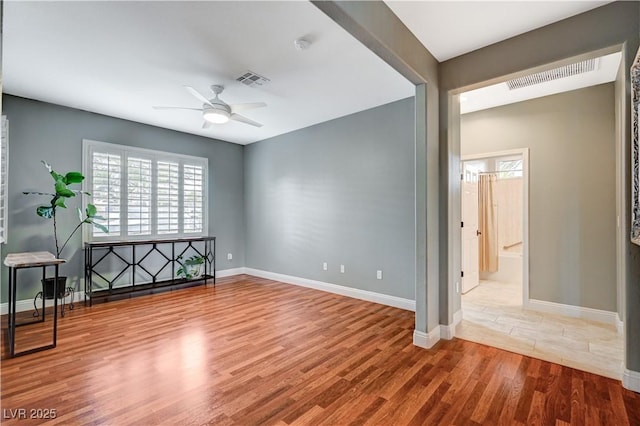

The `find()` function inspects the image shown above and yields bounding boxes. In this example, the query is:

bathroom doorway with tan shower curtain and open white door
[461,153,528,305]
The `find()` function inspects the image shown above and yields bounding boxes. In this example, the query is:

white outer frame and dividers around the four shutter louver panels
[82,139,209,243]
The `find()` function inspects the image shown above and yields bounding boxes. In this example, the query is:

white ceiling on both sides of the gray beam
[3,1,608,144]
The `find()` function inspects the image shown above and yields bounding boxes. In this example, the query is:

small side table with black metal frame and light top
[4,251,66,358]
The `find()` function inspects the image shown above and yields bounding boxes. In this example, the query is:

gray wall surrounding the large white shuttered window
[2,95,245,301]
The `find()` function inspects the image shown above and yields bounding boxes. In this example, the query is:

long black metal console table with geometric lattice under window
[84,237,216,305]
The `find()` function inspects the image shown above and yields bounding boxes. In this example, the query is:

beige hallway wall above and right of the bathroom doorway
[460,83,617,311]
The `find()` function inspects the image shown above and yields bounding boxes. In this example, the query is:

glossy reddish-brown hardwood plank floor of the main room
[1,276,640,425]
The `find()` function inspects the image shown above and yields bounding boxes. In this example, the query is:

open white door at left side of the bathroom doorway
[461,171,480,293]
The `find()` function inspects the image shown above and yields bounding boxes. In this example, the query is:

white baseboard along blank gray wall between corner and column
[245,268,416,312]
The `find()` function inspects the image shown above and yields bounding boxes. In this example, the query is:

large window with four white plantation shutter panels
[83,140,208,241]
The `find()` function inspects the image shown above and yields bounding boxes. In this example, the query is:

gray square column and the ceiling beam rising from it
[312,0,440,334]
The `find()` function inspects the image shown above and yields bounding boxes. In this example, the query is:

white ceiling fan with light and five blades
[153,84,267,129]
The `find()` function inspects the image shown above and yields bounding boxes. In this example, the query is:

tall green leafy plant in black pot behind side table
[24,161,109,299]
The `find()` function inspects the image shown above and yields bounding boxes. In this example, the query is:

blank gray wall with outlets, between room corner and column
[245,98,415,300]
